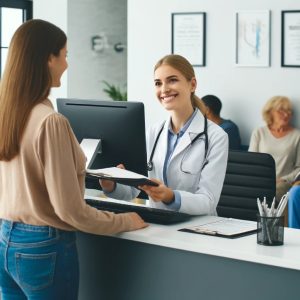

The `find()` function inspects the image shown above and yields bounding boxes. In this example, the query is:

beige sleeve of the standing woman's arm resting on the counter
[36,114,133,234]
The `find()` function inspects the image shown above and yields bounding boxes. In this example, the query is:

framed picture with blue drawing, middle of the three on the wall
[235,10,271,67]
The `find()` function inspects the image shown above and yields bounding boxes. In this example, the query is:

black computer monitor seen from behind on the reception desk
[57,99,147,189]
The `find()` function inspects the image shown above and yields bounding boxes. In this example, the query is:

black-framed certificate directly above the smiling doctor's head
[172,12,206,67]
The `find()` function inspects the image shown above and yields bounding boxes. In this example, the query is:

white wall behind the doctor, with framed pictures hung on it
[127,0,300,144]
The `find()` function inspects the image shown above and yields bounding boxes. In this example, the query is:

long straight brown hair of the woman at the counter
[0,19,67,161]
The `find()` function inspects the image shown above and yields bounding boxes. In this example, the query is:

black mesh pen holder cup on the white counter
[257,215,284,246]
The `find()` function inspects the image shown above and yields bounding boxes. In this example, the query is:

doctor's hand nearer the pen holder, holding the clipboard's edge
[138,178,175,204]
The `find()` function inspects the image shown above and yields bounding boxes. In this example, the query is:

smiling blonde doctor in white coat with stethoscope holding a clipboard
[100,55,228,215]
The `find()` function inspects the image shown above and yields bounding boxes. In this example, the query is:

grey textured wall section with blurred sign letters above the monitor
[68,0,127,100]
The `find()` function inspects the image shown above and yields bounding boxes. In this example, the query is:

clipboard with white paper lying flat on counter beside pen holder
[179,218,257,238]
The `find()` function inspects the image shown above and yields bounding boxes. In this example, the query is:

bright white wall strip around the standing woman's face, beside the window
[33,0,68,107]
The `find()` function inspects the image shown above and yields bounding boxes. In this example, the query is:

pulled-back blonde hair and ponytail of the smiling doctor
[154,54,206,115]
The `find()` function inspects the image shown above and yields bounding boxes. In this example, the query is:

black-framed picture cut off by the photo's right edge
[281,10,300,68]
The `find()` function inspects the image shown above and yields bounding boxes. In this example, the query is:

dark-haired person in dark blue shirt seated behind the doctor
[202,95,241,150]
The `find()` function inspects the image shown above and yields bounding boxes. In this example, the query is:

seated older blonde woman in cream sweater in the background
[249,96,300,210]
